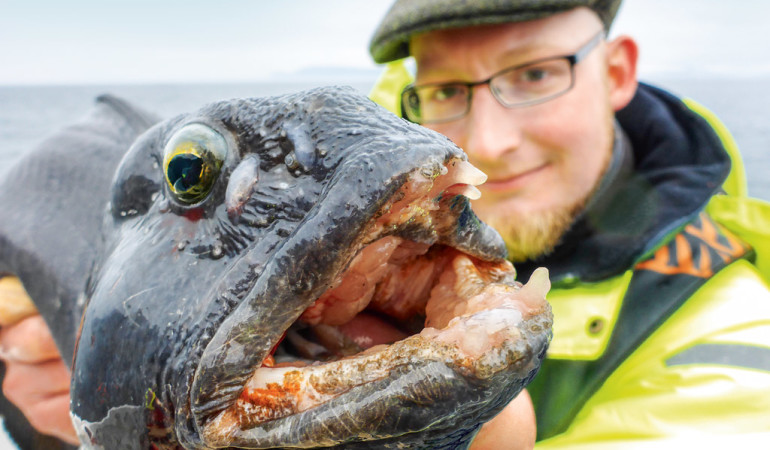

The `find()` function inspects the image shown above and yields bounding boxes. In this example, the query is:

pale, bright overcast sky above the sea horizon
[0,0,770,85]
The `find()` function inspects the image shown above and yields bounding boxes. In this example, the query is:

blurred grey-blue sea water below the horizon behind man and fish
[0,79,770,200]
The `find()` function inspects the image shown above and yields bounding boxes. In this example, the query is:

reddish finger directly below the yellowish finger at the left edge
[0,314,60,363]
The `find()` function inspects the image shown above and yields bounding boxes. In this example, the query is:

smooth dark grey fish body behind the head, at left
[0,95,159,363]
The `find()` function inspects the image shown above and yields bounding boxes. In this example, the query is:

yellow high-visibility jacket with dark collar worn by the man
[371,62,770,449]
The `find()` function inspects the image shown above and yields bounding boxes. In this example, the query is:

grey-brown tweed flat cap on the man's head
[369,0,621,63]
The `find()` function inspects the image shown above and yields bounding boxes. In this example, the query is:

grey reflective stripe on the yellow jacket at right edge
[666,344,770,372]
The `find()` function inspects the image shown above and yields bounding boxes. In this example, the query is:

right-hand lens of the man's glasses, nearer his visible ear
[490,58,572,106]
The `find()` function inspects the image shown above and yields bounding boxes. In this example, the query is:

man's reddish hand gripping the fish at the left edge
[0,315,79,444]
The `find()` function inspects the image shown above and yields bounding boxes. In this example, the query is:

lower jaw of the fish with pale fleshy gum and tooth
[204,273,551,448]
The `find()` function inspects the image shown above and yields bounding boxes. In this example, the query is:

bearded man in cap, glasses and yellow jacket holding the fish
[370,0,770,448]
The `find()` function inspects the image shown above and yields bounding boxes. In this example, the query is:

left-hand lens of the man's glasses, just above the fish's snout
[402,84,468,123]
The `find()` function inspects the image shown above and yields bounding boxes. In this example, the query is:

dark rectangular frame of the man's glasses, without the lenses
[400,30,604,125]
